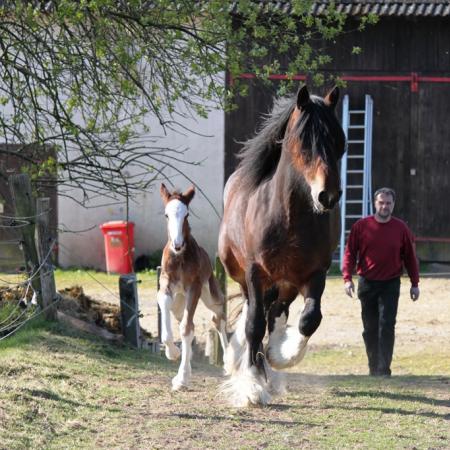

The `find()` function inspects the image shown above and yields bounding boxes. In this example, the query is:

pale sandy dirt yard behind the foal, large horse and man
[85,277,450,350]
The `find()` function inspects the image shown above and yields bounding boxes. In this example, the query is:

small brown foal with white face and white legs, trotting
[157,184,227,390]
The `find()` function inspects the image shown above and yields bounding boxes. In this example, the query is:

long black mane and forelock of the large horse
[238,96,344,189]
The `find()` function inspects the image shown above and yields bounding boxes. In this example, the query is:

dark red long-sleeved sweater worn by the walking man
[342,216,419,287]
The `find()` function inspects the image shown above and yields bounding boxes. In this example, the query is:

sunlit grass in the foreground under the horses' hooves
[0,320,450,450]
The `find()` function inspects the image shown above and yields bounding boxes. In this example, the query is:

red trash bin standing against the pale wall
[100,220,134,274]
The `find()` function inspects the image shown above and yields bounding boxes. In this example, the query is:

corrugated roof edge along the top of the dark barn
[239,0,450,17]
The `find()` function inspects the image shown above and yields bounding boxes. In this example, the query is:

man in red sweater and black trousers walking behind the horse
[342,188,420,376]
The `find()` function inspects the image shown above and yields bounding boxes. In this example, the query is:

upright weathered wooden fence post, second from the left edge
[36,197,57,320]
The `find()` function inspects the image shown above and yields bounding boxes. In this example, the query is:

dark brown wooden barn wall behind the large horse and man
[225,17,450,261]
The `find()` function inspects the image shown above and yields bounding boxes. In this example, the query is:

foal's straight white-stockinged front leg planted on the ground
[172,283,201,391]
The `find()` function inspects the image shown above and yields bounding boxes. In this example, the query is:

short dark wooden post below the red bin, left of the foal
[119,274,142,348]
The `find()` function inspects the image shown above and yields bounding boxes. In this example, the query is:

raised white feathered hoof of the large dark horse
[267,314,309,369]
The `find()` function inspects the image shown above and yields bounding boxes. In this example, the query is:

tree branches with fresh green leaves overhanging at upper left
[0,0,375,199]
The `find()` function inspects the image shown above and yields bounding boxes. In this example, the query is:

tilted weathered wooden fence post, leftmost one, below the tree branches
[8,173,44,308]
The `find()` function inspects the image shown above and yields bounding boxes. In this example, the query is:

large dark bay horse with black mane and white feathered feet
[219,86,345,406]
